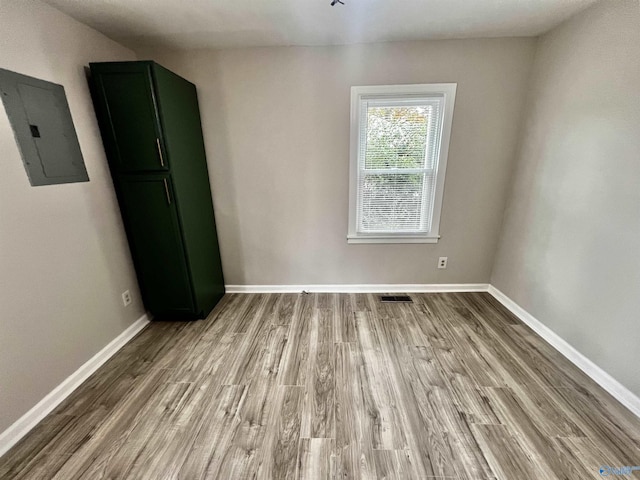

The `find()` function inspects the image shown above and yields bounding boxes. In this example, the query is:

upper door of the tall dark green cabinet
[91,63,169,172]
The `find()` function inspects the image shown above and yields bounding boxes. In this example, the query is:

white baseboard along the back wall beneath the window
[225,283,489,293]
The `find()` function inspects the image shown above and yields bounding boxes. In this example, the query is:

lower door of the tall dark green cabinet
[117,175,194,315]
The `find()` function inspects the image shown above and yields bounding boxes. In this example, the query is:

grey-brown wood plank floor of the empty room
[0,293,640,480]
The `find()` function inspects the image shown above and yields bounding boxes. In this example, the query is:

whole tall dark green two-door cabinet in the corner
[90,61,224,318]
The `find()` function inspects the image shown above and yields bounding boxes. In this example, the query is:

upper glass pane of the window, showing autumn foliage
[364,105,434,169]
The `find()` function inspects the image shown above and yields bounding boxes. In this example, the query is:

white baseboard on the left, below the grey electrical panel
[0,313,149,457]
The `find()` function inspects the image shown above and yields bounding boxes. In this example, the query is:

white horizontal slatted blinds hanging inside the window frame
[356,94,444,235]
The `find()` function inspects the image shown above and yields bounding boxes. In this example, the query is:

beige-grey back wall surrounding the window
[138,38,535,284]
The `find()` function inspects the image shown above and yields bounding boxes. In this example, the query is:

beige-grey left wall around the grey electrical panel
[0,0,143,433]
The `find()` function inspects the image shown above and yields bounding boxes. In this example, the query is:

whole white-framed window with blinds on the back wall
[347,83,456,243]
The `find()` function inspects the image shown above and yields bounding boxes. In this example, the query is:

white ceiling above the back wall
[45,0,594,49]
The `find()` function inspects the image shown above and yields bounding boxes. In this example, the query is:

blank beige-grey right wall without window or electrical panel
[492,0,640,395]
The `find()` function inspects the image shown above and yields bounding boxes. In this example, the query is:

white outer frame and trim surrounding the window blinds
[347,83,457,243]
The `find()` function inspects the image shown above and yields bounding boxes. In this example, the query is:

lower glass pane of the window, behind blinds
[359,173,432,233]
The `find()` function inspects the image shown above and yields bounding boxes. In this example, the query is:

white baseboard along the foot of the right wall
[489,285,640,417]
